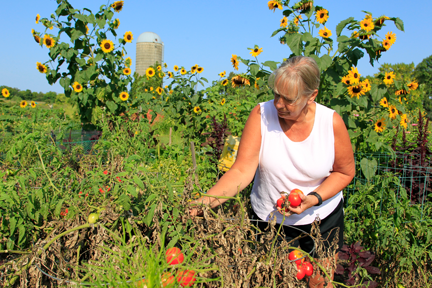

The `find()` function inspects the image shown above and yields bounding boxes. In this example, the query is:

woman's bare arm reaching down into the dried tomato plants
[190,105,261,215]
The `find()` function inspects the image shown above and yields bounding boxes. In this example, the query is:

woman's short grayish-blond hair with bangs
[268,56,320,100]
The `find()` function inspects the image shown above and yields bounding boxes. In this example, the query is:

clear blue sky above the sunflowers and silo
[0,0,432,93]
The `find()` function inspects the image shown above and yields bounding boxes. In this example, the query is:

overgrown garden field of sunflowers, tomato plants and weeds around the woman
[0,0,432,288]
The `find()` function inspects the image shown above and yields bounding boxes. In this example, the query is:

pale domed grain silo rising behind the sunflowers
[135,32,164,75]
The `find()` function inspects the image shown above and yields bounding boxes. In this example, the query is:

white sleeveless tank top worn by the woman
[251,100,343,225]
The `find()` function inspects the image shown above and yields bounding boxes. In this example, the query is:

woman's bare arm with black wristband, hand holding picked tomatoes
[289,112,355,214]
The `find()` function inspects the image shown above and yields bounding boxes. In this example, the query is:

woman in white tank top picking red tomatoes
[190,56,355,287]
